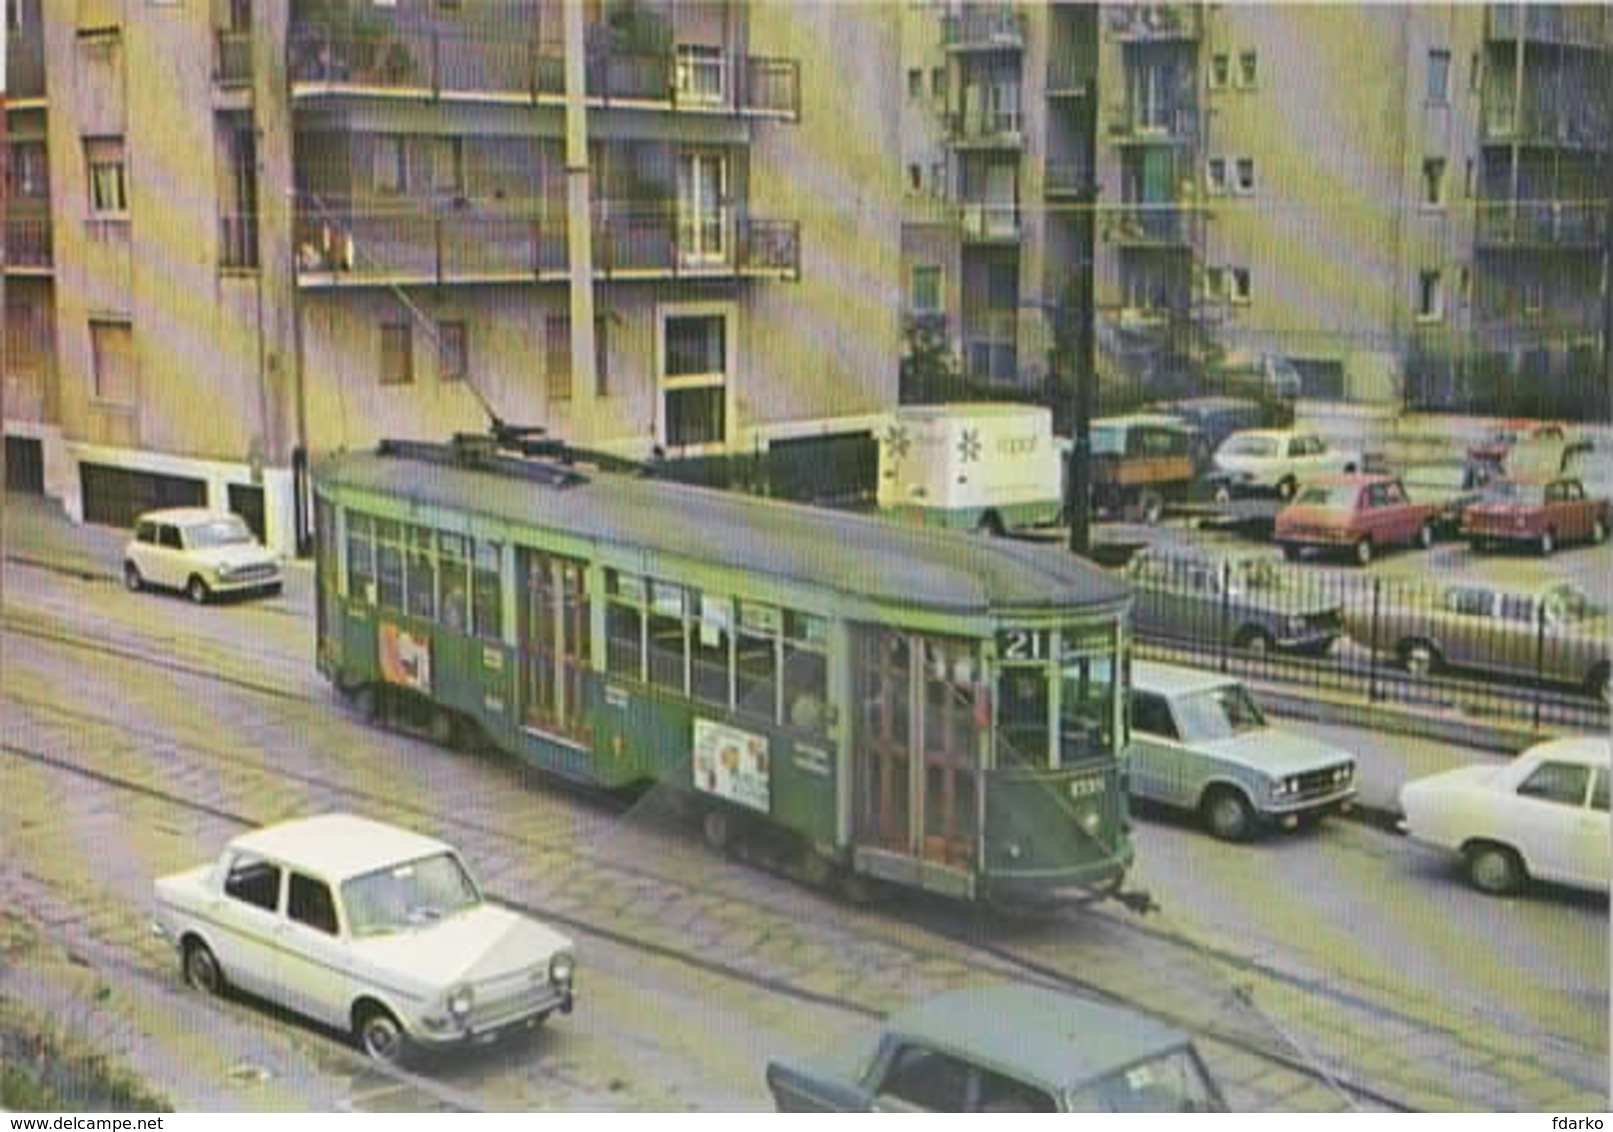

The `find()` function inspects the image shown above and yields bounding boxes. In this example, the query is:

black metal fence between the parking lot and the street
[1131,553,1610,730]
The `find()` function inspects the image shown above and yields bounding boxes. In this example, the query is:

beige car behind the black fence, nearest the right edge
[1344,581,1610,703]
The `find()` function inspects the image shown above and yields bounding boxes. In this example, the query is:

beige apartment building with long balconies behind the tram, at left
[5,0,902,548]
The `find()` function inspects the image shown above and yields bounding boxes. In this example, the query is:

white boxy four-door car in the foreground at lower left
[153,814,576,1063]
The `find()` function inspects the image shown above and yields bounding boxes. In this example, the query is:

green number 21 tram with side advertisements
[304,439,1132,901]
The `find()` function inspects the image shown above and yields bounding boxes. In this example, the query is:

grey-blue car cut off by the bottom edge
[768,984,1227,1113]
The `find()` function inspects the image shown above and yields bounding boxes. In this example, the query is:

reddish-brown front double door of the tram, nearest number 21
[857,629,982,869]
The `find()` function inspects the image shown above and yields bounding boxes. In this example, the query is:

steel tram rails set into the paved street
[0,612,1522,1111]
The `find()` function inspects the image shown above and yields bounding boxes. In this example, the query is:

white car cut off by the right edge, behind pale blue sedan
[1400,735,1613,895]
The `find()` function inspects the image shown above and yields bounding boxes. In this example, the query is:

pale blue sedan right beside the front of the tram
[1126,661,1355,842]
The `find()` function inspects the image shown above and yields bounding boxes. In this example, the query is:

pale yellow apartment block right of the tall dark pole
[1095,5,1613,413]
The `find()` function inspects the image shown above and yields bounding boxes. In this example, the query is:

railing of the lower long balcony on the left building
[297,202,800,287]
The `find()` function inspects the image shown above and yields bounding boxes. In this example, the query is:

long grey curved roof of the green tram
[315,452,1129,614]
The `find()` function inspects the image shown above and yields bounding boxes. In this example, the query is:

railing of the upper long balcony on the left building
[289,24,800,118]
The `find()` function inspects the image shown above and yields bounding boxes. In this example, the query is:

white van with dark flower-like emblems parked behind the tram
[877,403,1063,534]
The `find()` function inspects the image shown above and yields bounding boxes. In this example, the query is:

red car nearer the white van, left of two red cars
[1276,474,1437,566]
